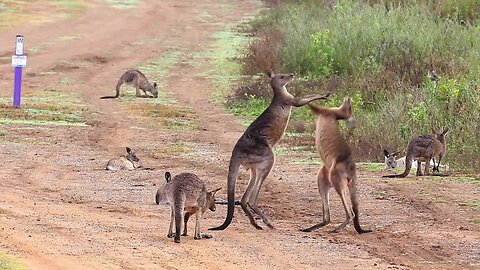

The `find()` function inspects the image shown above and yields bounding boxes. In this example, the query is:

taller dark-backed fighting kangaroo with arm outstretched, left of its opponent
[210,73,329,230]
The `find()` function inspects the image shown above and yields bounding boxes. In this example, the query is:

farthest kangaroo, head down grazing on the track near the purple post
[101,69,158,99]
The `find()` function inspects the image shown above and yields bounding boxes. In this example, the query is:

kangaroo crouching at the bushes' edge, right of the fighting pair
[383,129,448,178]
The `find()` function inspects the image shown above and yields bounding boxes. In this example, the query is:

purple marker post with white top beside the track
[12,35,27,108]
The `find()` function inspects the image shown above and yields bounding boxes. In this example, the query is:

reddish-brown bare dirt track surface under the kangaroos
[0,0,480,269]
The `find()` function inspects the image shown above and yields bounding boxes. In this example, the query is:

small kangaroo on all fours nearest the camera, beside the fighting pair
[155,172,221,243]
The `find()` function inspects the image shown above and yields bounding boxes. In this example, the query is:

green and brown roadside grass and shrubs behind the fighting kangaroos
[227,0,480,173]
